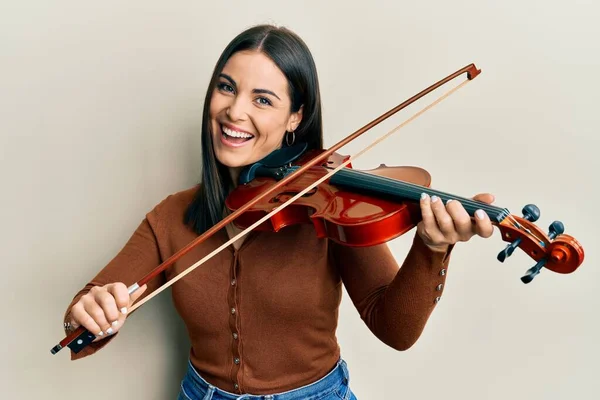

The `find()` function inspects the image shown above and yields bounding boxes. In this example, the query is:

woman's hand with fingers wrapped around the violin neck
[417,193,494,252]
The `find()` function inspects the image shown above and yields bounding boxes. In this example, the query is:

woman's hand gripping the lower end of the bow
[69,282,147,341]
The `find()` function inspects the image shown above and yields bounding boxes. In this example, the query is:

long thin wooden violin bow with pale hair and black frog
[50,64,482,354]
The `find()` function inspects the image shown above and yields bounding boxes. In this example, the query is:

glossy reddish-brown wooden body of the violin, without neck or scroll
[225,150,431,247]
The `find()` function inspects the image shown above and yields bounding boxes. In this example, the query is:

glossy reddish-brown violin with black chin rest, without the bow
[225,143,584,276]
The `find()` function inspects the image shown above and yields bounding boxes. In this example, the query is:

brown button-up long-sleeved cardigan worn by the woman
[65,187,451,394]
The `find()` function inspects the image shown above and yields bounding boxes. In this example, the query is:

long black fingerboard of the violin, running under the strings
[330,168,509,223]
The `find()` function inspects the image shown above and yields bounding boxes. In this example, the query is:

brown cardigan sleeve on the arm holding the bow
[64,205,165,360]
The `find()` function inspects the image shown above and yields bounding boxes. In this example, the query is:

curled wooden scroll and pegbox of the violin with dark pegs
[498,204,585,284]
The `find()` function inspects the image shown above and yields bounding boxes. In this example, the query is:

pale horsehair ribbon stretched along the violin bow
[128,79,470,315]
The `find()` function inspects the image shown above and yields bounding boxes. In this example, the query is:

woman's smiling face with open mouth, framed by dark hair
[210,51,302,174]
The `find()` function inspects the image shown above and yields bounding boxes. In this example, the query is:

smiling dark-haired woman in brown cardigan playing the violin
[65,25,493,400]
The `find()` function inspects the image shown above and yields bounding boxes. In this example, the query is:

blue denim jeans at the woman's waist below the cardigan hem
[177,359,357,400]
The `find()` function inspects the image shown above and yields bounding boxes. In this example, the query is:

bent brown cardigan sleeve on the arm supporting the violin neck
[332,234,454,350]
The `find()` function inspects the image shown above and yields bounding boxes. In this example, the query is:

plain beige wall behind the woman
[0,0,600,400]
